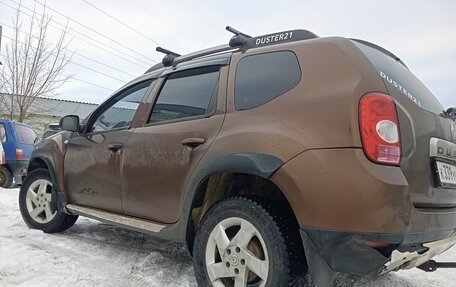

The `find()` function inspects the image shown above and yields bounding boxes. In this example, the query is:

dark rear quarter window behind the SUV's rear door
[234,51,301,110]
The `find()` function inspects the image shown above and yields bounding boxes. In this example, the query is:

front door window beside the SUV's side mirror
[90,80,152,132]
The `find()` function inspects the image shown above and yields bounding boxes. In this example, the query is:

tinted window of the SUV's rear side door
[149,66,220,123]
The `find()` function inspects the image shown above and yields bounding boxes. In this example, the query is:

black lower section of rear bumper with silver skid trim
[300,228,456,278]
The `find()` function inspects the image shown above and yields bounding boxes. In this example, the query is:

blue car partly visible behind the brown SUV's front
[0,120,37,188]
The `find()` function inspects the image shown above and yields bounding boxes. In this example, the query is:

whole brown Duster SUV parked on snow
[19,28,456,287]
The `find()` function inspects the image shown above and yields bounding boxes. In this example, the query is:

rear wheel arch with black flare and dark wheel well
[183,153,300,251]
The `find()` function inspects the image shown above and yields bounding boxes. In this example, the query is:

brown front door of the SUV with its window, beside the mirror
[64,80,151,213]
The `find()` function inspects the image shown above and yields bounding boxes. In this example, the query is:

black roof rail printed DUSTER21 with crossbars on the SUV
[153,26,318,72]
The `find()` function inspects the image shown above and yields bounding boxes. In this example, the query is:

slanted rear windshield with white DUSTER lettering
[352,41,444,114]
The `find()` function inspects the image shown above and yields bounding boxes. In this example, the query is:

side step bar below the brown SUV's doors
[66,204,165,233]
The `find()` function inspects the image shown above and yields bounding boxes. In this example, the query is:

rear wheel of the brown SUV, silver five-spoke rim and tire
[193,197,307,287]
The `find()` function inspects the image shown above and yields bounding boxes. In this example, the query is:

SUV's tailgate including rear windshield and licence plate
[353,40,456,209]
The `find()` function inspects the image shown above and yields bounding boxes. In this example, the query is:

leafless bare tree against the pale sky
[0,4,73,122]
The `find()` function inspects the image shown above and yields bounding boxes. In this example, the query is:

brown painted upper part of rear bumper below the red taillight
[271,148,456,236]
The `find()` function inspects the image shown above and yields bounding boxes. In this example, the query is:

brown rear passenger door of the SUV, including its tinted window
[122,65,227,223]
